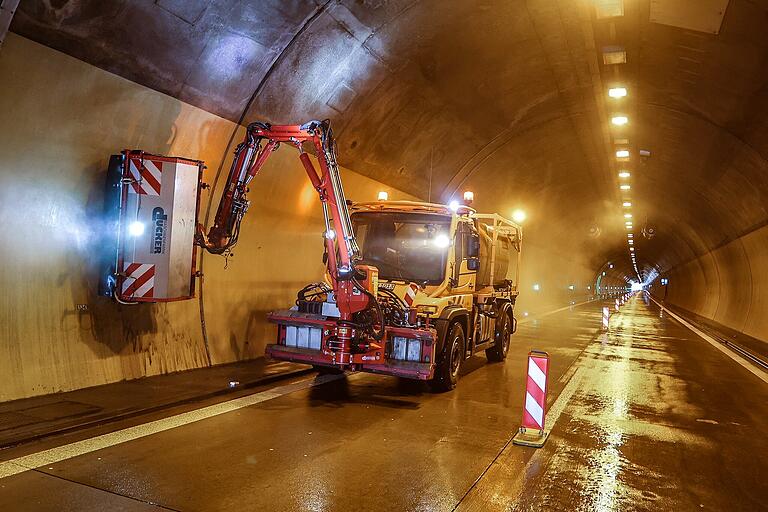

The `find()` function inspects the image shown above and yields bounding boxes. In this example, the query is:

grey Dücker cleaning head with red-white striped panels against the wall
[100,150,205,303]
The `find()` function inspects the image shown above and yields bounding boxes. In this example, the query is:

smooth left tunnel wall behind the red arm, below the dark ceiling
[0,34,594,401]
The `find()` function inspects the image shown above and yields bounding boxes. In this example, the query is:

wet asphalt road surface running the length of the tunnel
[0,294,768,511]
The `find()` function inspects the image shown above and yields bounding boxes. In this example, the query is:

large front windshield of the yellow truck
[352,212,451,284]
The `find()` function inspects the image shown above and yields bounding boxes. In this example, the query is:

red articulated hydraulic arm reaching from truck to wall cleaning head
[196,121,360,282]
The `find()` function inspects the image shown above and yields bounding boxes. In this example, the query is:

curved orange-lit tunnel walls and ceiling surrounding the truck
[0,0,768,399]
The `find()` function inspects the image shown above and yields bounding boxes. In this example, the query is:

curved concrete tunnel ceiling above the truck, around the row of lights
[12,0,768,279]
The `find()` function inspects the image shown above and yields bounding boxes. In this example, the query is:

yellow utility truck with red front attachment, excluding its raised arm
[267,201,522,390]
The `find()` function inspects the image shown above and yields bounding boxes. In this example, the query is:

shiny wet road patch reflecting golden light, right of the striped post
[513,312,711,512]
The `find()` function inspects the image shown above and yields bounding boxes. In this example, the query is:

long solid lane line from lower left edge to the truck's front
[0,375,344,479]
